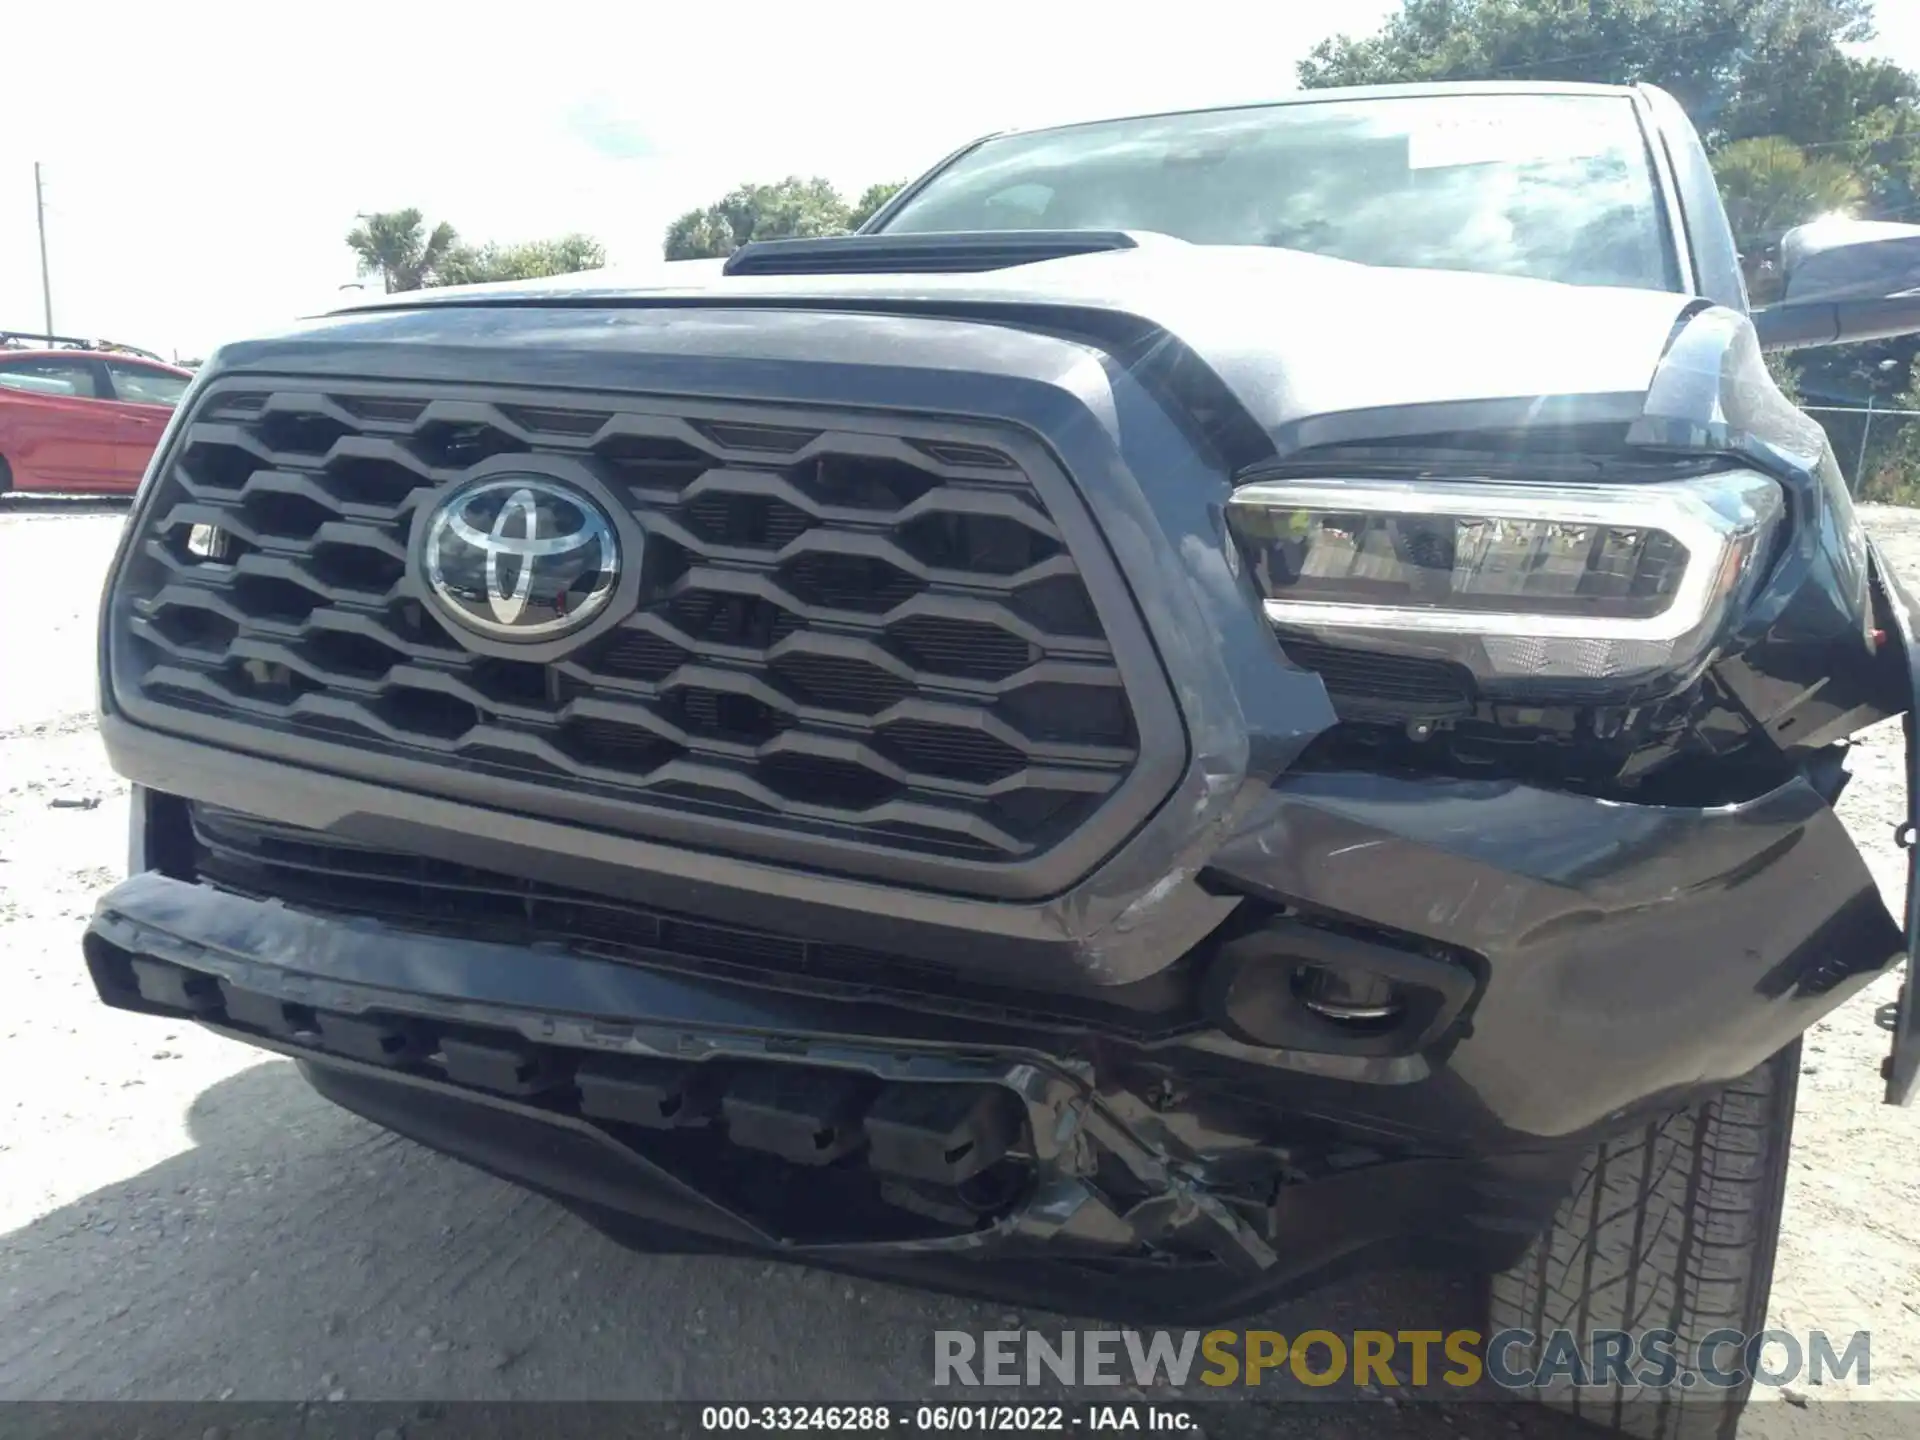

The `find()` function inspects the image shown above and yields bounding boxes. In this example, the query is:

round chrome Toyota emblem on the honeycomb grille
[420,474,620,641]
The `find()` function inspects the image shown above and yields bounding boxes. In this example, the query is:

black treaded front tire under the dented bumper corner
[1488,1041,1801,1440]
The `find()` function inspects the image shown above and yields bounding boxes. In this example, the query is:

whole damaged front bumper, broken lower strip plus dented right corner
[84,737,1901,1319]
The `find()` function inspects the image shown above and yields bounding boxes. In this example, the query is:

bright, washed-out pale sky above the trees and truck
[0,0,1920,353]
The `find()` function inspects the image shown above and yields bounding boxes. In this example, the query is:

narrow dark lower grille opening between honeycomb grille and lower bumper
[186,804,1194,1037]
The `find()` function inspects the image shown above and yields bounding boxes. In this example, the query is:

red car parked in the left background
[0,334,194,495]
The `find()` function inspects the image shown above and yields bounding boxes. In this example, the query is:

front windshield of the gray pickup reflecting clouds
[883,94,1680,290]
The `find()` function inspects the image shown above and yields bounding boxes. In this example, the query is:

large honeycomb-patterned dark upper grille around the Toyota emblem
[115,382,1139,870]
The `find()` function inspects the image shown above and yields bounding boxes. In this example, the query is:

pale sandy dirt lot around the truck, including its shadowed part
[0,501,1920,1436]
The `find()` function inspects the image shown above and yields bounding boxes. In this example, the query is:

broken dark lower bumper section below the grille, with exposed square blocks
[84,872,1459,1315]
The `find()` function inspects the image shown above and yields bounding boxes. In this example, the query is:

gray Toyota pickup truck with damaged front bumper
[84,84,1920,1436]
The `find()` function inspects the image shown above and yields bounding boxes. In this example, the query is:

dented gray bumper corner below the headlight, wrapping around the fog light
[1213,772,1905,1146]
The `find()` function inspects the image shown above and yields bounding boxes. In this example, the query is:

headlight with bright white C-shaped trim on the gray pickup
[1229,470,1784,685]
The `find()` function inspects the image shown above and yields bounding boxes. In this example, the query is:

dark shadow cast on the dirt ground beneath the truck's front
[0,1060,1565,1434]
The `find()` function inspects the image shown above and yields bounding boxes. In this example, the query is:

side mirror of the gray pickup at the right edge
[1753,219,1920,349]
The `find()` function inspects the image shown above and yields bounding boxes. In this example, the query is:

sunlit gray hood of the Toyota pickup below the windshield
[318,236,1699,449]
